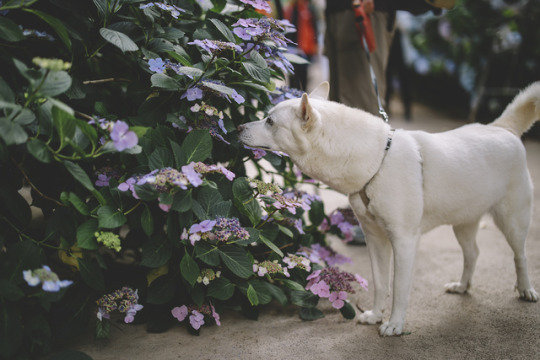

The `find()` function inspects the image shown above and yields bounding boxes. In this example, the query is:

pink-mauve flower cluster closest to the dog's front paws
[306,267,367,309]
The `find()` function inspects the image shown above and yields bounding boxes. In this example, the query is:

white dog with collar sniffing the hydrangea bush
[239,82,540,335]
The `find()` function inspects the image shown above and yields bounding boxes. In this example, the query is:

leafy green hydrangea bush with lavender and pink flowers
[0,0,365,358]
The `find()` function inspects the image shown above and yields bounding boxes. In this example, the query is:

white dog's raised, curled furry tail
[491,81,540,137]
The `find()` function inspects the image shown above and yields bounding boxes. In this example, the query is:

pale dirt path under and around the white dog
[78,104,540,360]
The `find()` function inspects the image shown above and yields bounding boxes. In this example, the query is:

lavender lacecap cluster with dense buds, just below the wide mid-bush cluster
[186,218,250,245]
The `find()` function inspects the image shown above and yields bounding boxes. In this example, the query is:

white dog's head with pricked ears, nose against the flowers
[238,81,330,155]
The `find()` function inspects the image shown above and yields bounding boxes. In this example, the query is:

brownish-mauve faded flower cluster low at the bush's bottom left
[96,286,143,324]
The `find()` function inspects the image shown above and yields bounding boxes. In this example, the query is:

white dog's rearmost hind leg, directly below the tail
[492,173,538,302]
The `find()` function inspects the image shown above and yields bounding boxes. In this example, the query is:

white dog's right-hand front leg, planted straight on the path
[379,235,419,336]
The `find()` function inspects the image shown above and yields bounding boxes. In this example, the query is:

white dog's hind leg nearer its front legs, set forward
[444,221,480,294]
